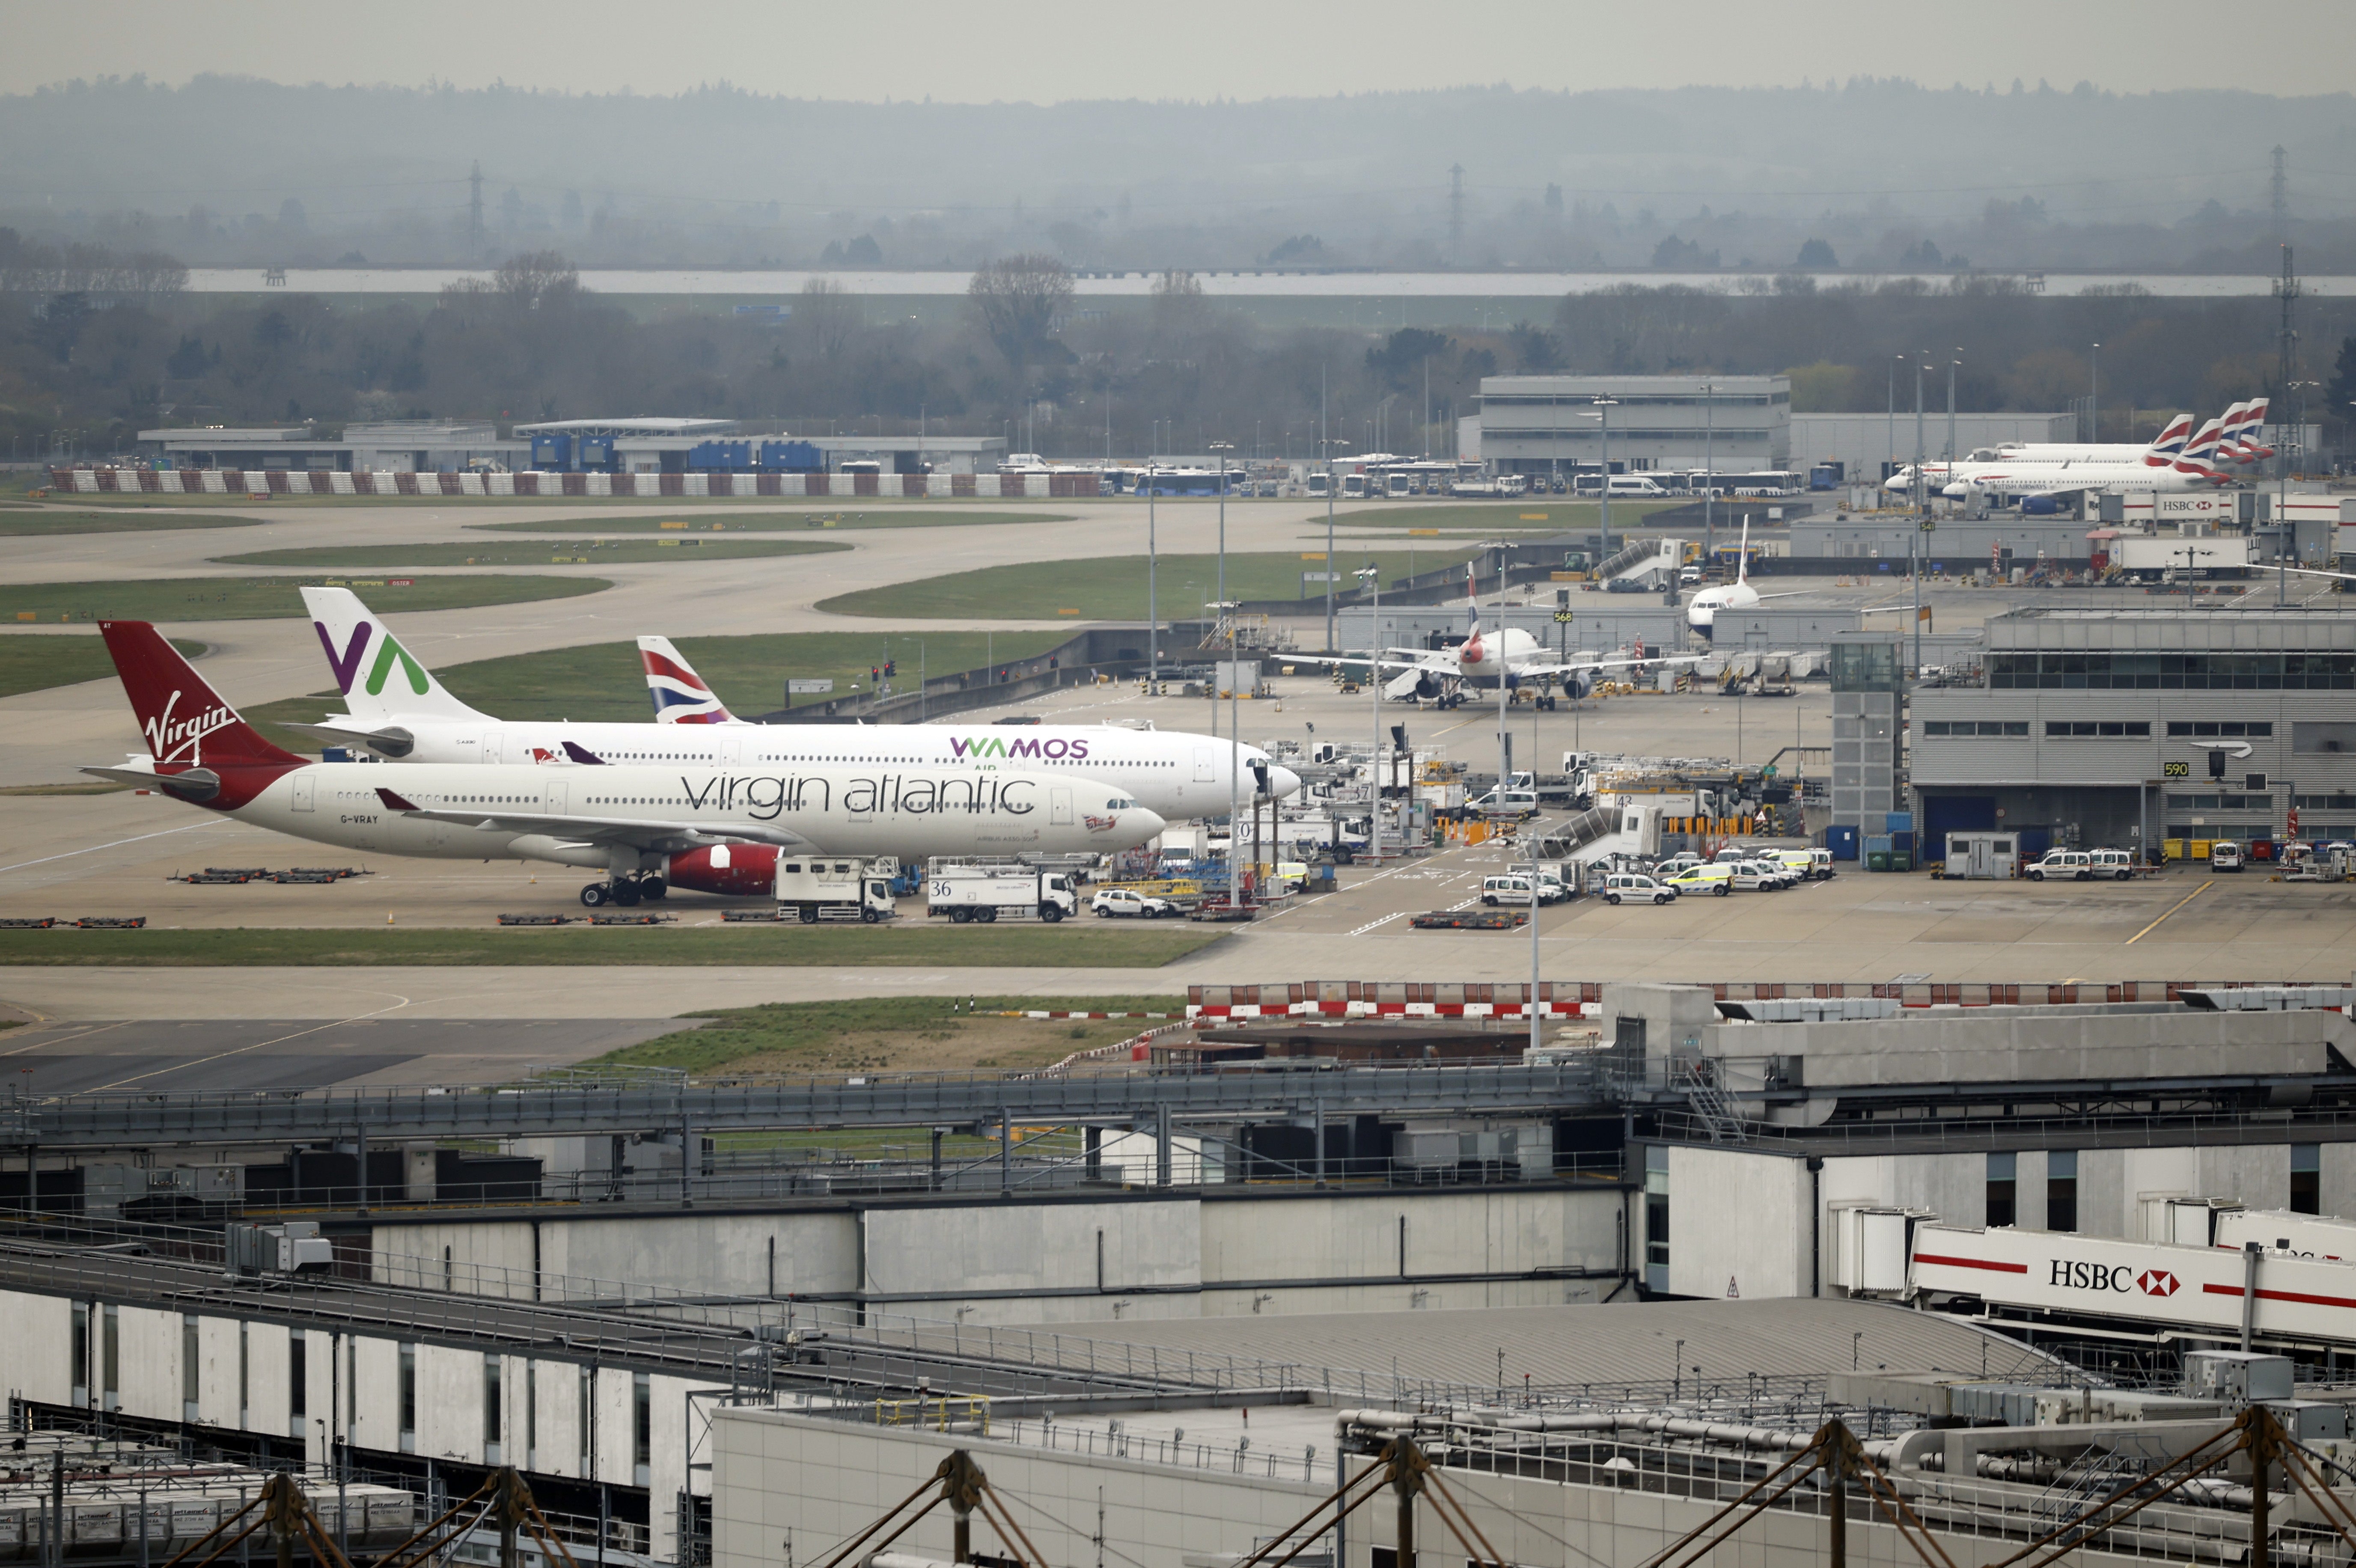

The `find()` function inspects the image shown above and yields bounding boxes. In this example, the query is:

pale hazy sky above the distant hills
[14,0,2349,101]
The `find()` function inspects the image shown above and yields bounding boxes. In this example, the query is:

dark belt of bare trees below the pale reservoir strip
[0,246,2356,457]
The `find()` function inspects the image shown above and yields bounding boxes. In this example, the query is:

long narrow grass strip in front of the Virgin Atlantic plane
[0,921,1228,970]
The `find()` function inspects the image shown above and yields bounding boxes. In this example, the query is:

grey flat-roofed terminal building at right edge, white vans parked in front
[1908,610,2356,857]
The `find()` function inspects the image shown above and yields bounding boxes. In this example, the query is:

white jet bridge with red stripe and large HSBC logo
[1908,1224,2356,1344]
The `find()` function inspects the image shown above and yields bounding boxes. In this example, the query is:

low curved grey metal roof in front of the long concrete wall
[1017,1297,2052,1387]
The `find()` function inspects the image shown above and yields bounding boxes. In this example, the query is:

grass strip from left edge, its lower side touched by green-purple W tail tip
[0,577,613,621]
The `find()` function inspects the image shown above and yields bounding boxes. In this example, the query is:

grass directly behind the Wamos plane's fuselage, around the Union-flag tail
[245,631,1062,734]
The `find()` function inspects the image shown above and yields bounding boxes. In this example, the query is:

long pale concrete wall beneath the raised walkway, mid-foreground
[375,1177,1621,1325]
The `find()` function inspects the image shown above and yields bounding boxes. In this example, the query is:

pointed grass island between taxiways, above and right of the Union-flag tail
[818,544,1472,621]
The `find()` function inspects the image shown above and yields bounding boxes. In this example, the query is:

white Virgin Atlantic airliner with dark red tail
[83,621,1164,906]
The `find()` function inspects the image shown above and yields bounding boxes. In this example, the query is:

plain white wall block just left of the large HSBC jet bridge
[1668,1144,1814,1297]
